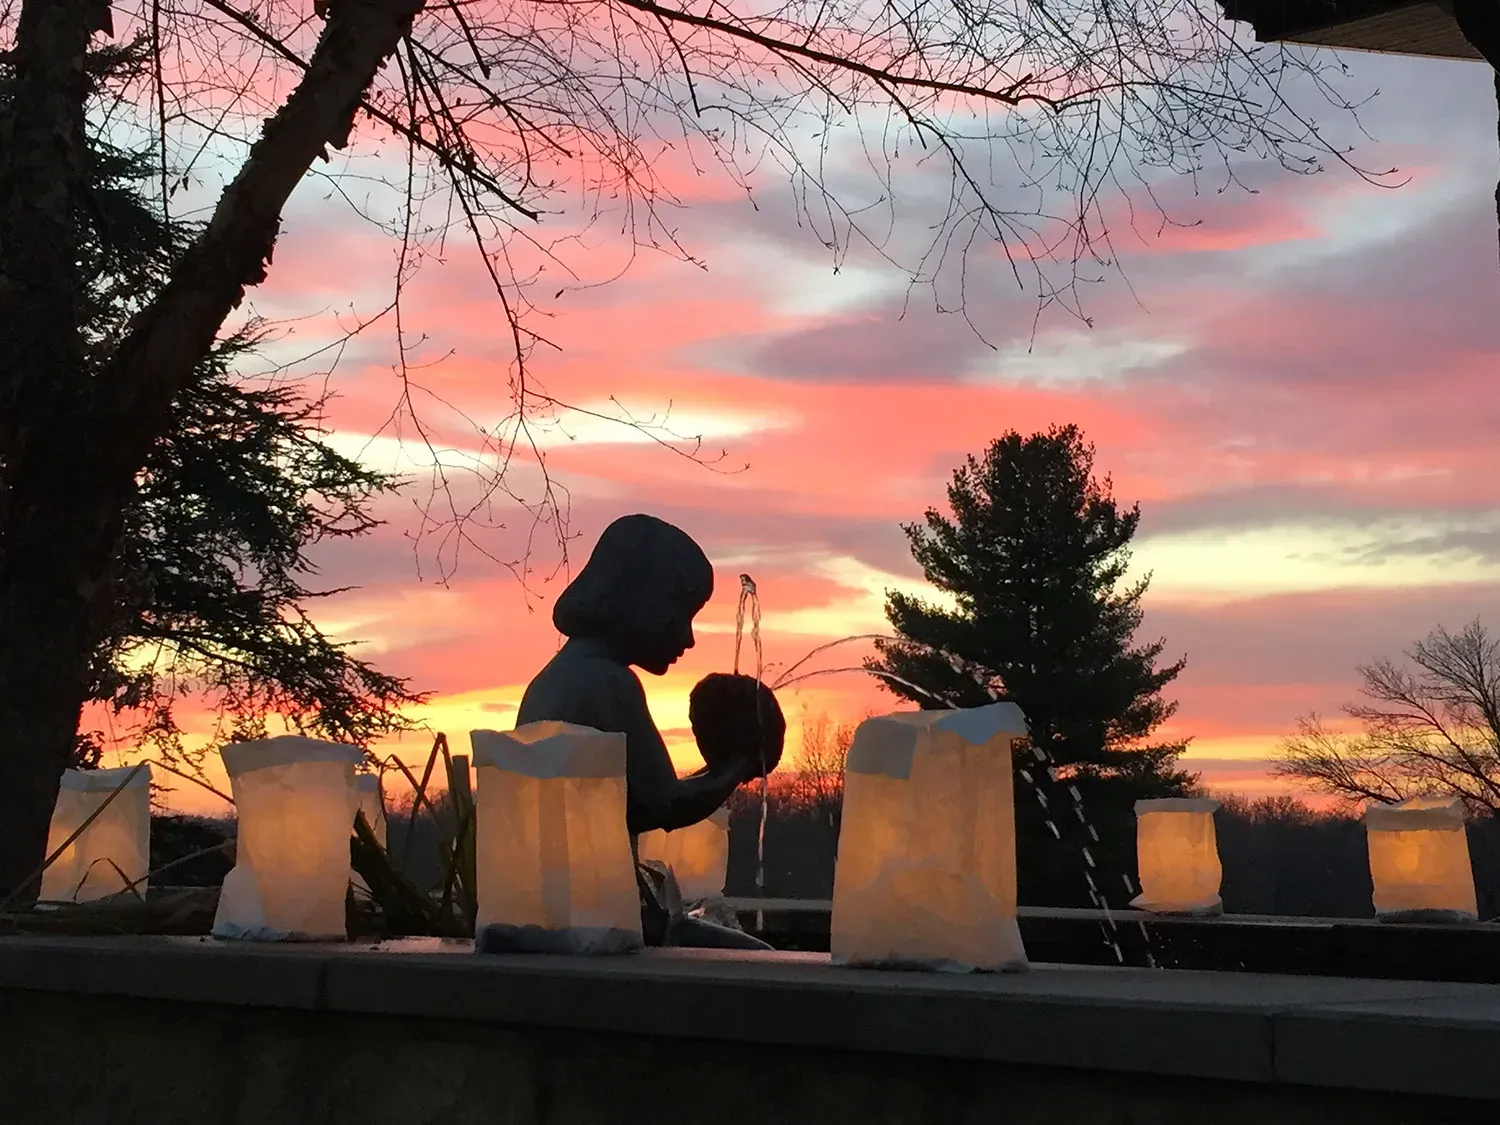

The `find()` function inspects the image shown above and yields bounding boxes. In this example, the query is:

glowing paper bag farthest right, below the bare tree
[1365,797,1479,921]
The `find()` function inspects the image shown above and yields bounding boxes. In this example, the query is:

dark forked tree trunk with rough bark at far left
[0,0,425,894]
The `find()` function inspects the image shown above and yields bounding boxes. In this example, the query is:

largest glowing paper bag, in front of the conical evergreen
[830,704,1026,972]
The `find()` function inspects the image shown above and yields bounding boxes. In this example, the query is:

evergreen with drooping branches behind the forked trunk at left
[61,48,420,767]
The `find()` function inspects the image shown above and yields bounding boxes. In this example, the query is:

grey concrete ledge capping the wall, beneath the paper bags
[0,938,1500,1098]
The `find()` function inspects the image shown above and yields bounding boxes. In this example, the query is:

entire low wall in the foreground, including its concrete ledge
[0,938,1500,1125]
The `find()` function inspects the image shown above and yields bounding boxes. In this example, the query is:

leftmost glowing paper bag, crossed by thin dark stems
[41,765,152,903]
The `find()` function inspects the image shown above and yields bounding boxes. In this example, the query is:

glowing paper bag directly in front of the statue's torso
[470,722,644,954]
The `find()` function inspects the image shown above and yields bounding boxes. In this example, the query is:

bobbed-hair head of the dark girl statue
[552,516,714,675]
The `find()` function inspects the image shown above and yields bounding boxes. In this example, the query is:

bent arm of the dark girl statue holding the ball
[617,674,747,833]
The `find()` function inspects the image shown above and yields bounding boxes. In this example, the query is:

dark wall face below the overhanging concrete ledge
[0,992,1476,1125]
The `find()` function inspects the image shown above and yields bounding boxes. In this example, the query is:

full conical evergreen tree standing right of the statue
[870,426,1194,905]
